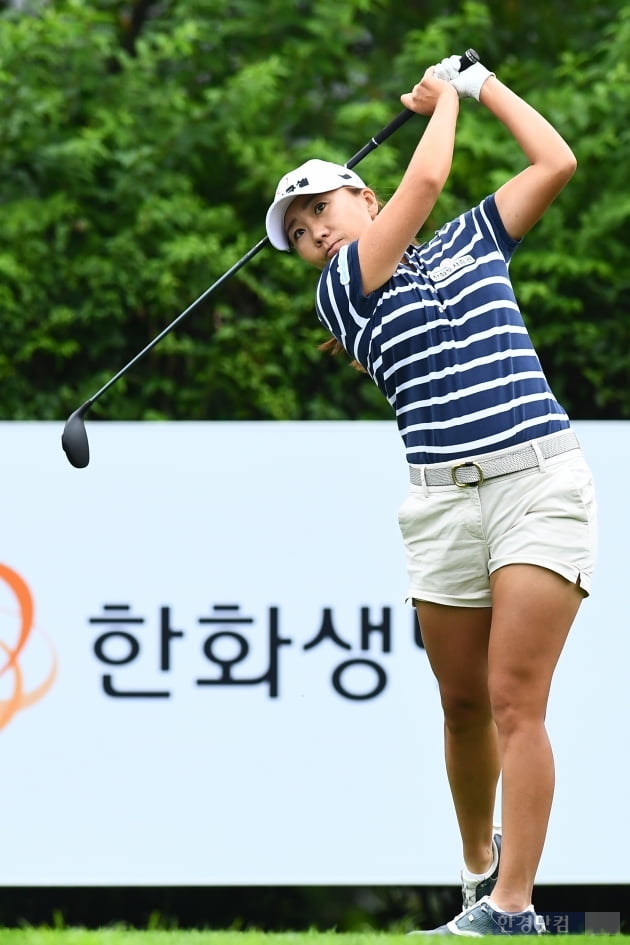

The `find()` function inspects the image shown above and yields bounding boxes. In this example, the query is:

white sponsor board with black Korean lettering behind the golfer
[0,421,630,886]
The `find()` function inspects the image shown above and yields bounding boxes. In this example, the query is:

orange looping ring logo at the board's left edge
[0,564,57,729]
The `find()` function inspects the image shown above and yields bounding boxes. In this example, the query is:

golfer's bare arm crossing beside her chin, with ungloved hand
[359,68,459,294]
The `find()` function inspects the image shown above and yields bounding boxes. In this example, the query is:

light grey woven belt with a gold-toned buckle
[409,430,580,488]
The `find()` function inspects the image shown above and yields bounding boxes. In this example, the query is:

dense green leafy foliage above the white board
[0,0,630,420]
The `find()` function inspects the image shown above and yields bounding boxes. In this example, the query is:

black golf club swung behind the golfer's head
[61,49,479,469]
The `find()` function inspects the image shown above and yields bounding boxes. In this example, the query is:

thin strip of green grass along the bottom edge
[0,928,627,945]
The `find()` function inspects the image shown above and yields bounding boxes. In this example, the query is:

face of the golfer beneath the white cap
[284,187,378,269]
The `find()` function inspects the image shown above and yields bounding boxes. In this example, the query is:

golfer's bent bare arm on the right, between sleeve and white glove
[479,76,577,239]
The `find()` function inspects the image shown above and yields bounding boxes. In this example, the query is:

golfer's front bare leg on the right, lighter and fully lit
[488,565,582,912]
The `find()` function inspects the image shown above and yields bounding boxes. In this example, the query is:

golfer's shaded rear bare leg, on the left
[416,601,499,873]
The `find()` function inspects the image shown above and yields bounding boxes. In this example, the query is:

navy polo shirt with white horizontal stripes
[316,195,569,464]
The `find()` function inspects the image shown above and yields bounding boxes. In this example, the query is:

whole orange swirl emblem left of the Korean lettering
[0,564,57,729]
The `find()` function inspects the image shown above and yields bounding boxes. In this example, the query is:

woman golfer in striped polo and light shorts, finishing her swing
[267,56,596,935]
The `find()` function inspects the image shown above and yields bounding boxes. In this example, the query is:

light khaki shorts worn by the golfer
[398,436,597,607]
